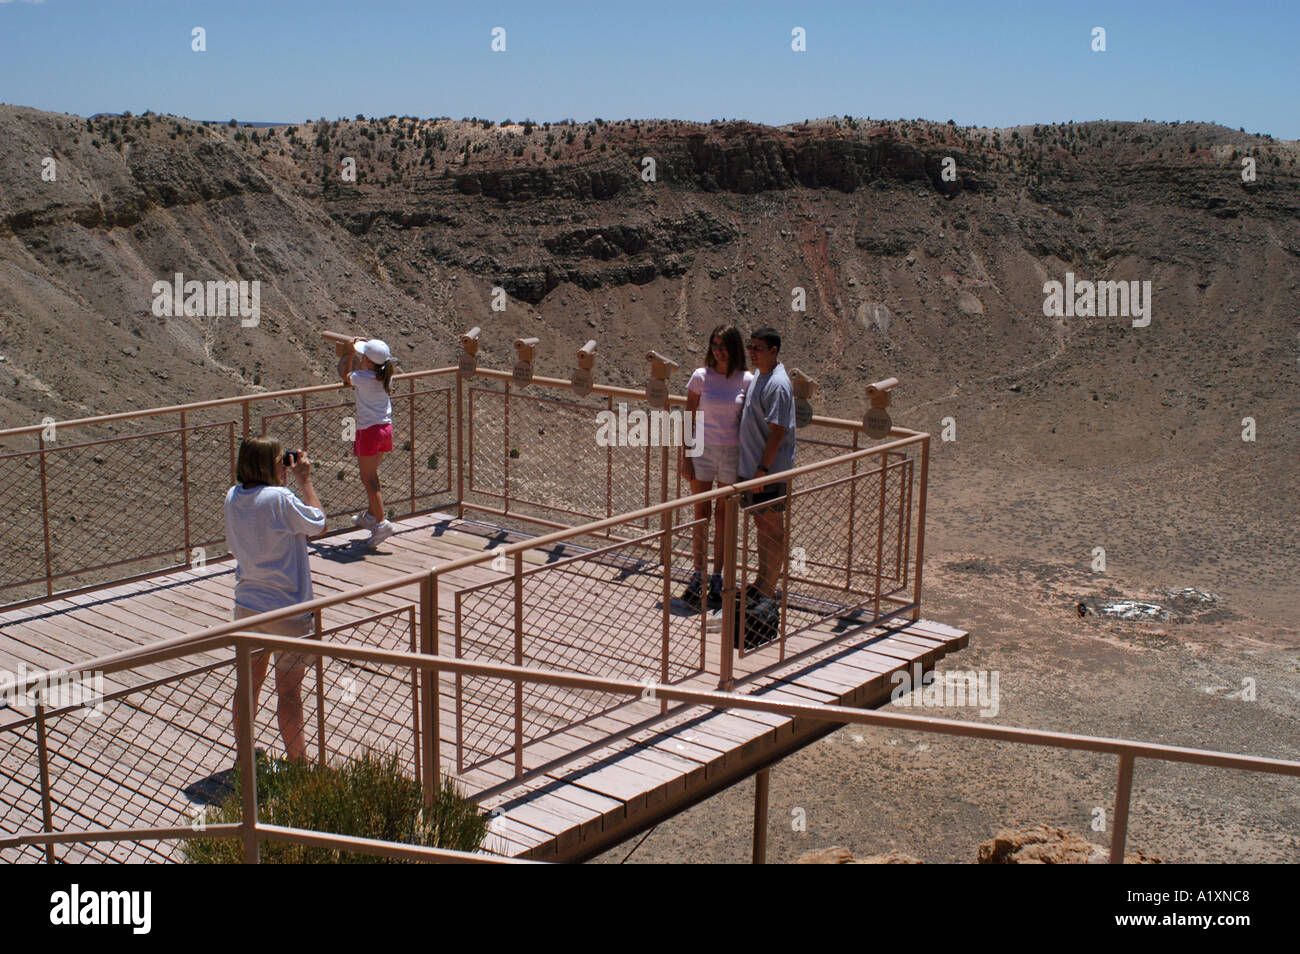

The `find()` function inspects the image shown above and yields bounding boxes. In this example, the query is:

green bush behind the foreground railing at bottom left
[182,751,488,864]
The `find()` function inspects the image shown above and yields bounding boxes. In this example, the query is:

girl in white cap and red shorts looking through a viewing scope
[338,338,397,550]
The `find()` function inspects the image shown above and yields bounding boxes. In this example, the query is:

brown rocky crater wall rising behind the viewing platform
[0,107,1300,613]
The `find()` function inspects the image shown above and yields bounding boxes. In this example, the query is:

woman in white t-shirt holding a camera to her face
[226,438,325,762]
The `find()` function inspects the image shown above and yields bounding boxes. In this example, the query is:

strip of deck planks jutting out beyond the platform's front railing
[484,620,969,862]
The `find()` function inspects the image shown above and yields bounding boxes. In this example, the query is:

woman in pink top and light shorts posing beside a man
[681,325,754,607]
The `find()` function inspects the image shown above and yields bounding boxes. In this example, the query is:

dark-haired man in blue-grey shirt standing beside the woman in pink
[736,328,794,610]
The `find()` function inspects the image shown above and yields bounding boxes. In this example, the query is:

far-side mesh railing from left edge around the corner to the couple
[0,368,883,607]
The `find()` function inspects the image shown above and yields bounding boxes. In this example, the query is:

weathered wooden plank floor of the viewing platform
[0,513,967,860]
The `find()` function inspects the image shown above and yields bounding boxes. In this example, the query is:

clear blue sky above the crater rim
[0,0,1300,139]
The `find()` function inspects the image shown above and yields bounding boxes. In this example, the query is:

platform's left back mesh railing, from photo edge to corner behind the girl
[0,368,456,606]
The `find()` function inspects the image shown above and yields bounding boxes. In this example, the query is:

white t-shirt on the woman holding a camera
[226,483,325,612]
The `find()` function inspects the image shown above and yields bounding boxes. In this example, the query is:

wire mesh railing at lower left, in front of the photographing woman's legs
[0,604,421,862]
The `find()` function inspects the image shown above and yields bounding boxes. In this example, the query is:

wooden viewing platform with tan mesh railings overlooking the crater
[0,343,967,862]
